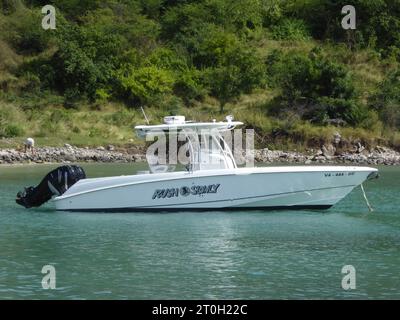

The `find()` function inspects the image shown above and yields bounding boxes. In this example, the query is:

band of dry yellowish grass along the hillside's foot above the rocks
[0,91,390,151]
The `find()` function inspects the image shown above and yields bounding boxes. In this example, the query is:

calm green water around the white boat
[0,164,400,299]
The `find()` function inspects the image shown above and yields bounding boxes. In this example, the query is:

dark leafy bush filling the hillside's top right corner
[283,0,400,53]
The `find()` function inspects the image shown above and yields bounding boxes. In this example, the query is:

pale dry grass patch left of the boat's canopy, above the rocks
[0,102,142,148]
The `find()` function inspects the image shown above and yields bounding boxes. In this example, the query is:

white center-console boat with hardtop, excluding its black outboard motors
[47,117,378,212]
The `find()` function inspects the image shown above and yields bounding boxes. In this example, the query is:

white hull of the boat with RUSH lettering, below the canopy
[54,166,377,212]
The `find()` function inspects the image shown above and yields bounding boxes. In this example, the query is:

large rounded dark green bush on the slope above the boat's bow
[267,49,364,125]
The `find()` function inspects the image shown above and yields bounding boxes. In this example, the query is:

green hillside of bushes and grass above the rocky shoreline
[0,0,400,150]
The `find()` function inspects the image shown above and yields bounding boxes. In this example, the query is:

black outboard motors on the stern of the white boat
[15,165,86,208]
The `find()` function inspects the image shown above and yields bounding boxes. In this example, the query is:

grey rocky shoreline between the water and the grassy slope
[0,144,400,165]
